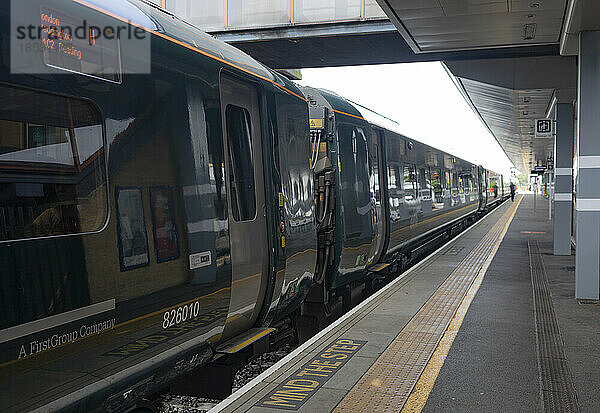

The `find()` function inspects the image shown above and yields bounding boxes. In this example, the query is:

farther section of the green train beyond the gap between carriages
[302,87,506,312]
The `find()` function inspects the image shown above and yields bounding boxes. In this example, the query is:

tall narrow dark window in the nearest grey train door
[225,105,256,221]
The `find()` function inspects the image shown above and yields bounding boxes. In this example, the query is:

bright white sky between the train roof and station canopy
[299,62,512,176]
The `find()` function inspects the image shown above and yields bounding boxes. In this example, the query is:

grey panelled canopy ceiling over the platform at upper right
[377,0,600,172]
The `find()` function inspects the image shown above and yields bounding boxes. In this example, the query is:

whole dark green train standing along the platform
[0,0,508,411]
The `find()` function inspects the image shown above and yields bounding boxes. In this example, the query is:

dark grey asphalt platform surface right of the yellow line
[423,194,600,413]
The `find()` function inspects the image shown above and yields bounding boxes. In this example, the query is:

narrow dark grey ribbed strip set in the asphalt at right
[527,240,579,412]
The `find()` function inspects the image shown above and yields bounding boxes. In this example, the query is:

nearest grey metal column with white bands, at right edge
[575,31,600,300]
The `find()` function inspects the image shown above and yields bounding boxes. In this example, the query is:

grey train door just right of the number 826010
[221,76,269,338]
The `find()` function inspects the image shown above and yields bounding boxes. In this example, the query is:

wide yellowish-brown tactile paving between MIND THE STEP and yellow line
[334,204,516,413]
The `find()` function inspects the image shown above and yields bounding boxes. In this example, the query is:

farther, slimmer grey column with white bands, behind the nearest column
[554,103,573,255]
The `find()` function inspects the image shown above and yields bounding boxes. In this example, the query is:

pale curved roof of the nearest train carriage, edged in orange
[71,0,304,100]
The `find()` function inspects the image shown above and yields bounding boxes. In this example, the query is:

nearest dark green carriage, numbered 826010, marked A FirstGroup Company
[0,0,316,411]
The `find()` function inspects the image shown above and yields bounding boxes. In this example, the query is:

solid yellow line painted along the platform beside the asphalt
[402,195,523,413]
